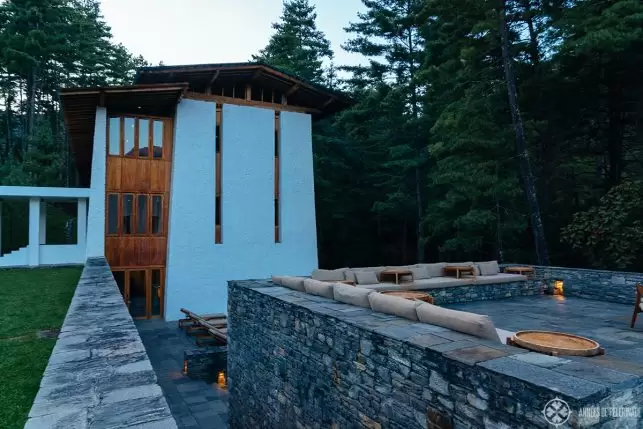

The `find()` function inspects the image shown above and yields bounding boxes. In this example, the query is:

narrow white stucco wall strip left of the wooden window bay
[86,107,107,258]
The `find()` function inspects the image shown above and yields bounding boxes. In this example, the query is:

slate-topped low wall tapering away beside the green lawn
[25,258,177,429]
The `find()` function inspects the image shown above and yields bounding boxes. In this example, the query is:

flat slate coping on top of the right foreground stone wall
[228,279,643,405]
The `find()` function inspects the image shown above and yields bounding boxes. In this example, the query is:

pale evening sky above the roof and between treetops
[101,0,364,65]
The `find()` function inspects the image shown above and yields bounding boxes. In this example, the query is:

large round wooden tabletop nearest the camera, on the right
[511,331,604,356]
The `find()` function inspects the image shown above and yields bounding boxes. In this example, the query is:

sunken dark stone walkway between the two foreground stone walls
[136,320,228,429]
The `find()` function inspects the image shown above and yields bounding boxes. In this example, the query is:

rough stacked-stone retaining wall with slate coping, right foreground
[228,280,643,429]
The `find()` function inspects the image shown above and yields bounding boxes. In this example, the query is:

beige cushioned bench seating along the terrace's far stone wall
[311,261,527,291]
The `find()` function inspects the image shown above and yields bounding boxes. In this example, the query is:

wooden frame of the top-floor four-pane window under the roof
[106,113,172,161]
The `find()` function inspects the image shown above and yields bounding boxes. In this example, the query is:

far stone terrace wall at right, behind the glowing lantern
[503,264,643,305]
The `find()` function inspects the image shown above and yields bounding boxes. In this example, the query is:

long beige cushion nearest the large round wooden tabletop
[417,303,501,342]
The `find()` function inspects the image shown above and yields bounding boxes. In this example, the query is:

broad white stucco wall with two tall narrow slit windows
[165,100,317,320]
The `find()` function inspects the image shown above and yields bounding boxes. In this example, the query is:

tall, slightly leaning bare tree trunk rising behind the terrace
[499,0,549,265]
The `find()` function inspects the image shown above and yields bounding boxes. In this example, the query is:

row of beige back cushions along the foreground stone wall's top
[272,276,504,343]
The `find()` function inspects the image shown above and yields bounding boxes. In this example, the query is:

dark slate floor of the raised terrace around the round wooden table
[446,295,643,374]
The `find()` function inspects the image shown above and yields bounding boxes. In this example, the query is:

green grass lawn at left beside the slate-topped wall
[0,267,82,429]
